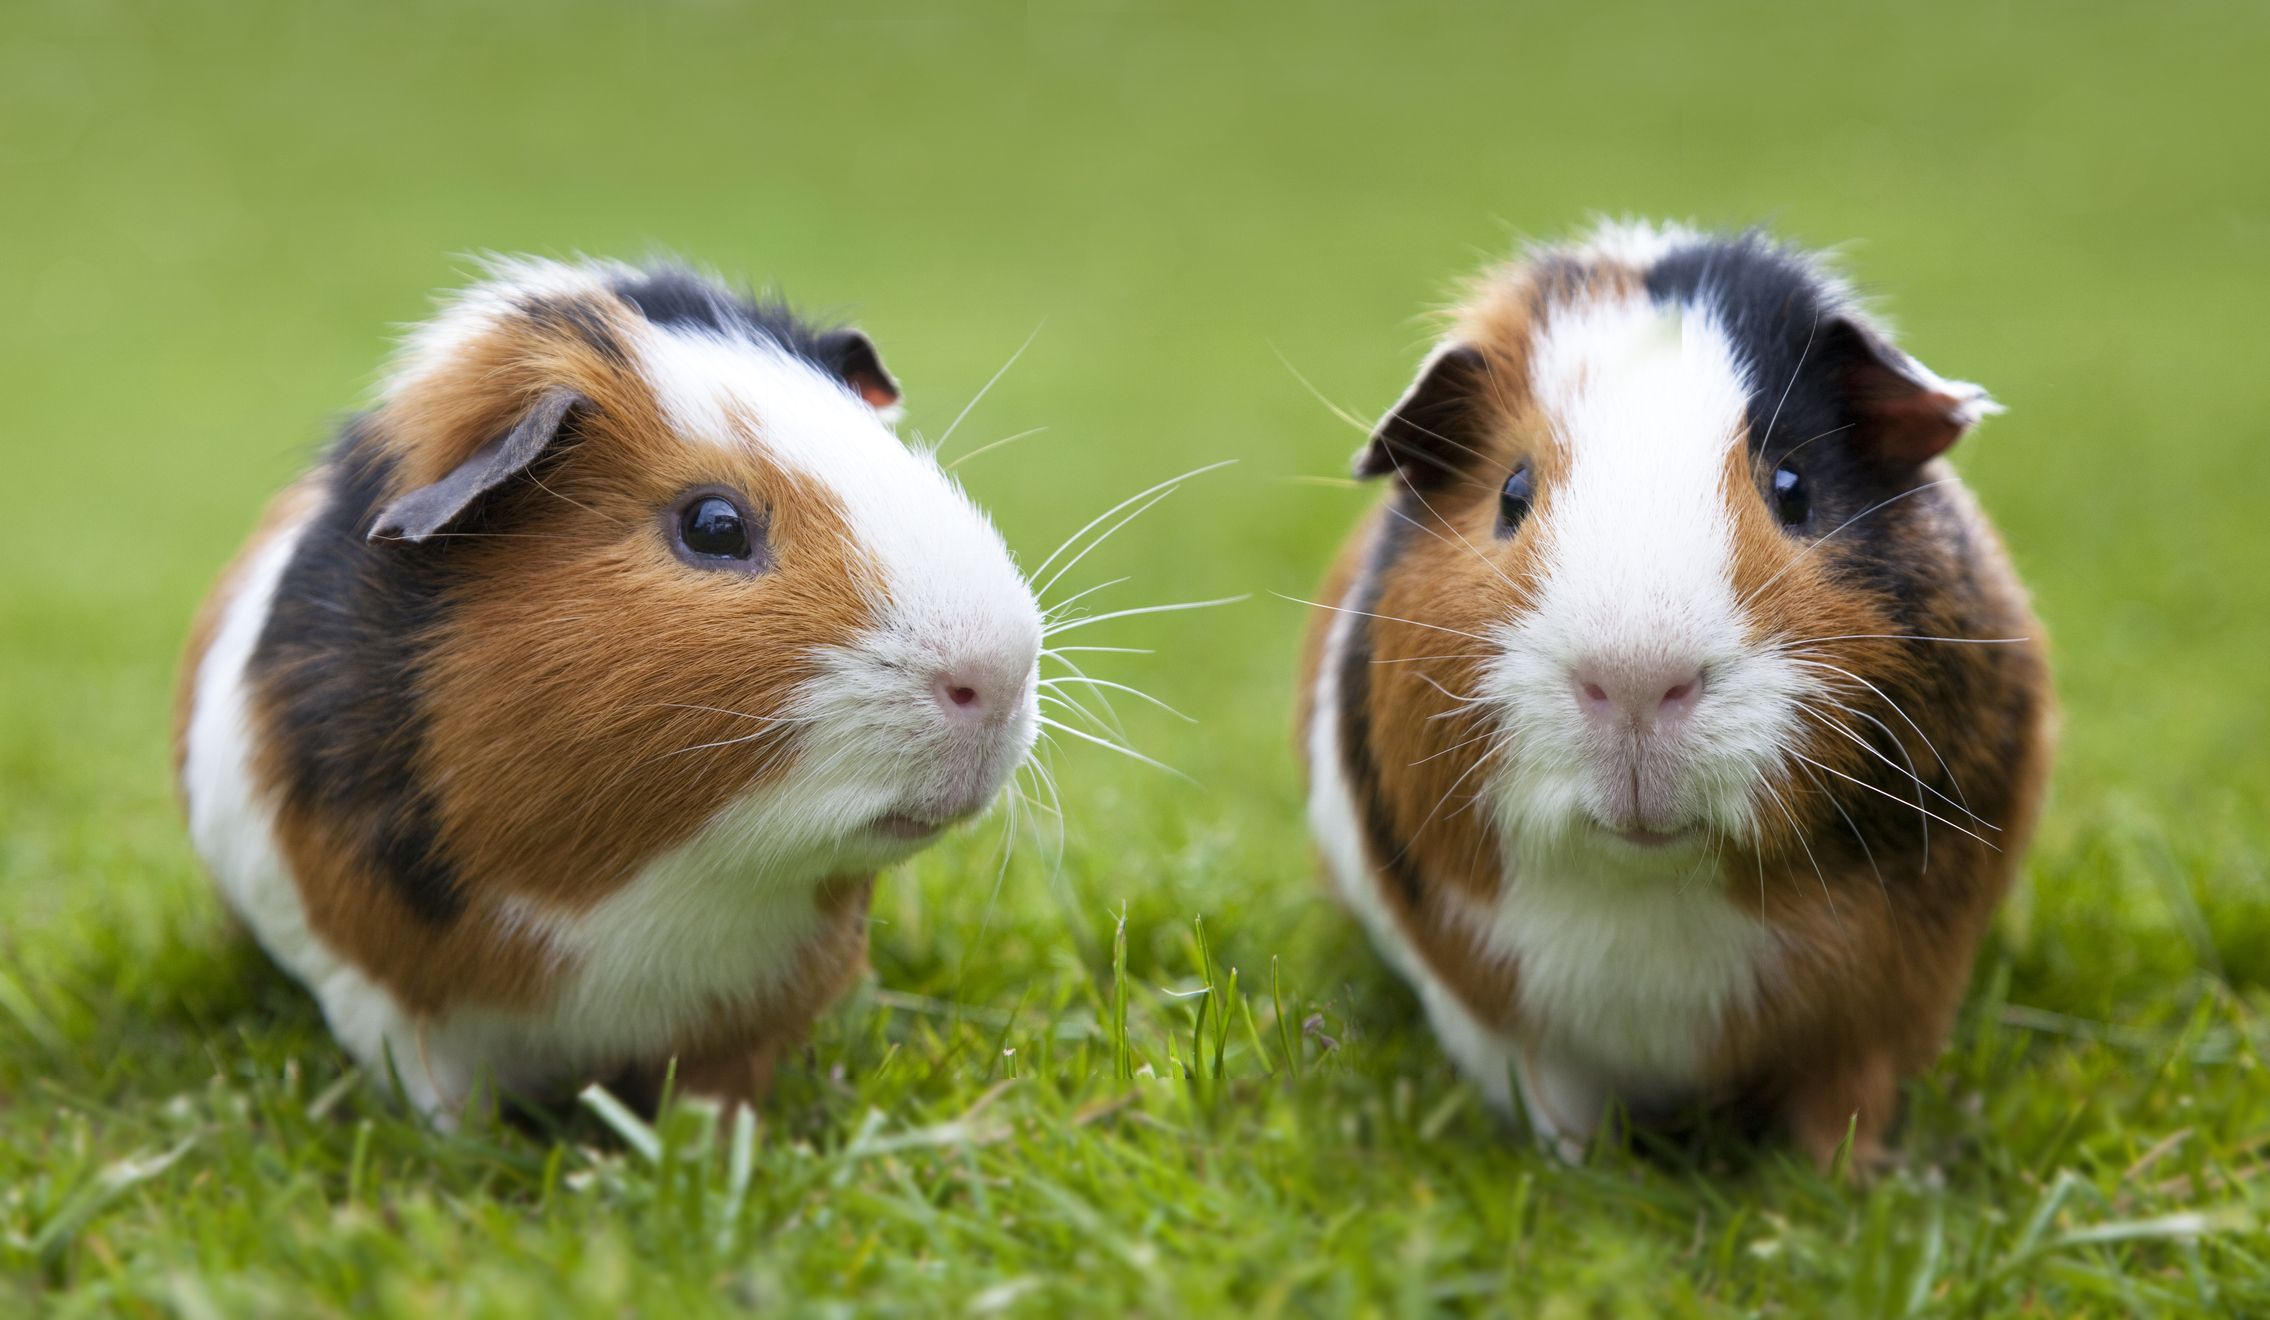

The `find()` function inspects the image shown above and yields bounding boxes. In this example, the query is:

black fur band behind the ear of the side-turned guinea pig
[247,418,465,925]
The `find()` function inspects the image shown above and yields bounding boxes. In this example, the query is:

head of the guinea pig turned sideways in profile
[358,259,1040,888]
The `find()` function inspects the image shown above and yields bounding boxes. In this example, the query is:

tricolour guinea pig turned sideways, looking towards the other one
[175,259,1042,1125]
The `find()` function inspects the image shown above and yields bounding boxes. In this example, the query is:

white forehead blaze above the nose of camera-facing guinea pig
[1532,293,1750,659]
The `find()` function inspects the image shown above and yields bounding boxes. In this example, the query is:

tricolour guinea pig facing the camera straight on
[1301,225,2054,1166]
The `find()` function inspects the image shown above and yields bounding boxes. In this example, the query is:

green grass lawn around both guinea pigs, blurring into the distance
[0,0,2270,1315]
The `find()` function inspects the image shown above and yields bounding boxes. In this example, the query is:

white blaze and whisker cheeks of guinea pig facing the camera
[1482,295,1809,854]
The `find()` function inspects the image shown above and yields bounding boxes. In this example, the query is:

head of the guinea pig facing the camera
[1357,227,1995,877]
